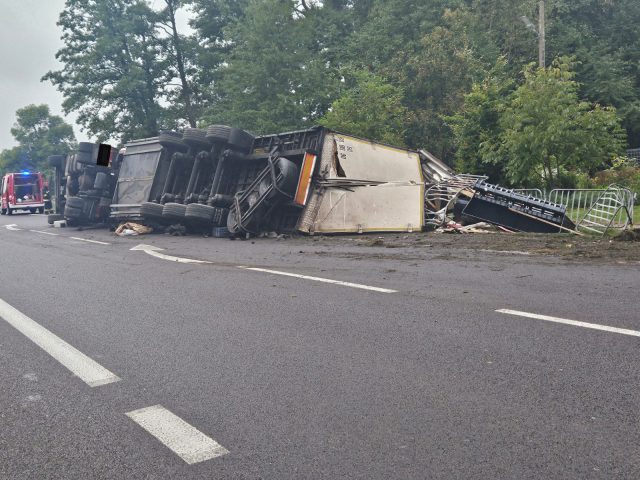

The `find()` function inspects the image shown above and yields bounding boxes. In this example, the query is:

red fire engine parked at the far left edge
[0,172,44,215]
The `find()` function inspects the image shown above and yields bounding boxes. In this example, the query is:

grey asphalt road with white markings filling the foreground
[0,215,640,480]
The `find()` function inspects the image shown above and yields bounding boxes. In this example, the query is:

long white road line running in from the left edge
[0,299,120,387]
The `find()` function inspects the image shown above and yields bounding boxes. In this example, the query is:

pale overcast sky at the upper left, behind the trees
[0,0,188,150]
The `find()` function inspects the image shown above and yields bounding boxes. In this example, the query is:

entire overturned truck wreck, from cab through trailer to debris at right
[50,125,626,237]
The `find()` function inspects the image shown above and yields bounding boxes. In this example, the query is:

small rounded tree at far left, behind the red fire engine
[0,105,75,171]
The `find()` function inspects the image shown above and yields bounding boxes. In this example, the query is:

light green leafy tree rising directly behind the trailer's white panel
[320,71,409,146]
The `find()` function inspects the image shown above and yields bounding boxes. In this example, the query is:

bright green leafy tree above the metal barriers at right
[499,58,626,188]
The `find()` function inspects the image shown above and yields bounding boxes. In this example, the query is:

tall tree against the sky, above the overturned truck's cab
[43,0,173,141]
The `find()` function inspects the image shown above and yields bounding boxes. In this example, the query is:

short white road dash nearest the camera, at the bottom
[127,405,229,464]
